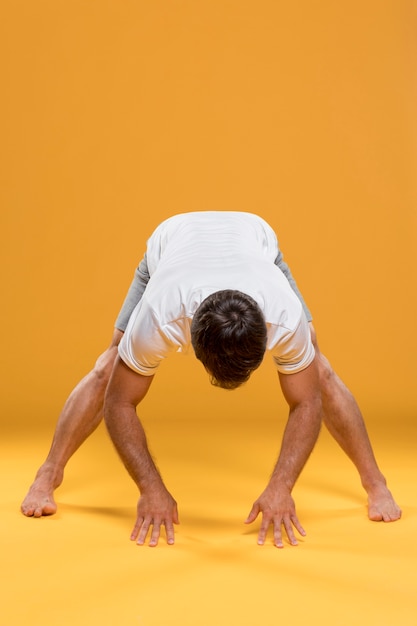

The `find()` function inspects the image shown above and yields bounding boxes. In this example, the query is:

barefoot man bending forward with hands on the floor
[22,212,401,547]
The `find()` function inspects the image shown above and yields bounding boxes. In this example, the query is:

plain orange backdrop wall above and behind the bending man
[0,0,417,422]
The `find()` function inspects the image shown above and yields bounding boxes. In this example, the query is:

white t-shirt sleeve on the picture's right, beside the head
[271,313,315,374]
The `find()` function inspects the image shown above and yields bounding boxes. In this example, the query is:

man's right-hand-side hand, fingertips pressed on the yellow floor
[245,487,306,548]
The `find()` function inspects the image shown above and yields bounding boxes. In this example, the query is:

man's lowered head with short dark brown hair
[191,289,267,389]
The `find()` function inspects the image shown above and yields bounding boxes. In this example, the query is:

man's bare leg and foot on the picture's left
[21,329,123,517]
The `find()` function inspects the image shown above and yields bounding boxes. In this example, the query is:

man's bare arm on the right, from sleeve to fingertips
[246,360,321,548]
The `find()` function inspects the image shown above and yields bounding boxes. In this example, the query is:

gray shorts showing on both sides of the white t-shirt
[115,252,313,332]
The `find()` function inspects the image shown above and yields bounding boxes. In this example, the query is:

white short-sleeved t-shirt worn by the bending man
[119,211,314,376]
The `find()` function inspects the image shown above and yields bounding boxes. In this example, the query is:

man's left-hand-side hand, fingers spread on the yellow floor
[130,487,179,547]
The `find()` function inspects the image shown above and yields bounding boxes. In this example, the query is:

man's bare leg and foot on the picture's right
[310,325,401,522]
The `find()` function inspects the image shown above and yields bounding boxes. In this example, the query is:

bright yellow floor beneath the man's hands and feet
[0,382,417,626]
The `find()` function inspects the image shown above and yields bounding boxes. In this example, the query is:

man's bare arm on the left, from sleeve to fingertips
[104,358,178,546]
